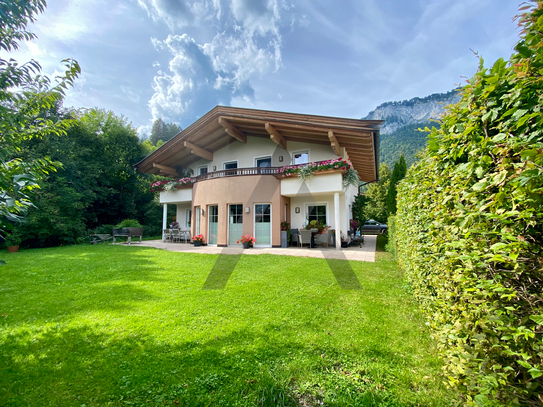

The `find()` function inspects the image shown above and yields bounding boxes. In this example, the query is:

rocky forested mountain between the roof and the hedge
[363,89,460,168]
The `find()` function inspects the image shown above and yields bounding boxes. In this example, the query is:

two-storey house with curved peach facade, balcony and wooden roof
[135,106,383,249]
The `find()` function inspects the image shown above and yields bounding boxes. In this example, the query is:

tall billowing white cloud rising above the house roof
[144,0,294,124]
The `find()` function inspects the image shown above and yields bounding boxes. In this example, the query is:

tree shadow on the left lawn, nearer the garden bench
[1,246,172,325]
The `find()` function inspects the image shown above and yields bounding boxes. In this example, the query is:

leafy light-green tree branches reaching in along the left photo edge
[0,0,81,262]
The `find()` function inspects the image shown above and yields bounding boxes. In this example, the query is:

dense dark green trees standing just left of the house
[19,109,162,247]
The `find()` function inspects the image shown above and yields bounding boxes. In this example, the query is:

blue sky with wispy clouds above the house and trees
[9,0,521,135]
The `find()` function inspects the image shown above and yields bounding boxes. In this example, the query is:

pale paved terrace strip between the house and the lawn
[134,235,377,262]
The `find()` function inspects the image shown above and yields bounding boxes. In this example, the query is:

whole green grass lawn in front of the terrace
[0,240,456,407]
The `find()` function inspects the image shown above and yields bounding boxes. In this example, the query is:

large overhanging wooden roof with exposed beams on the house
[136,106,383,182]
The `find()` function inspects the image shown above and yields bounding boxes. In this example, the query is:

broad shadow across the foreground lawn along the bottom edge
[0,326,408,406]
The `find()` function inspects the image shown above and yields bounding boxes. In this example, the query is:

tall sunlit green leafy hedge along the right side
[395,0,543,406]
